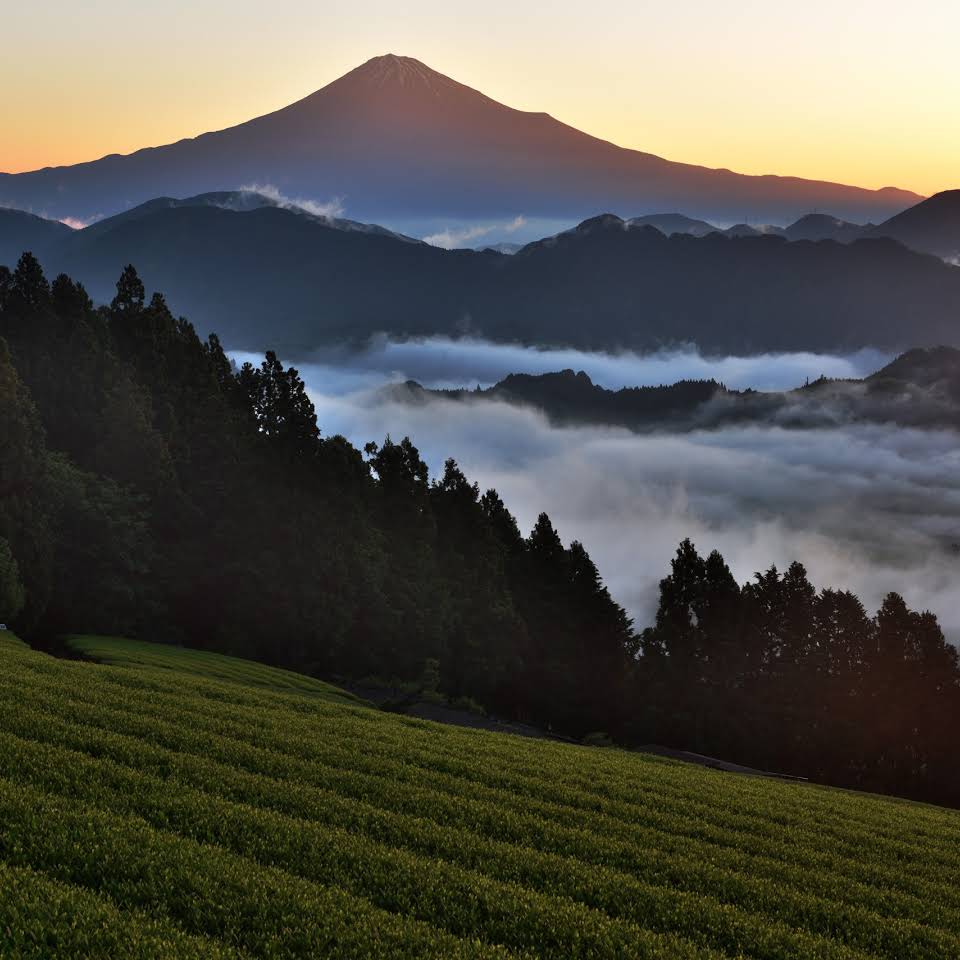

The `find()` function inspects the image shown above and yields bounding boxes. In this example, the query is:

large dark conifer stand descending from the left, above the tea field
[0,254,634,734]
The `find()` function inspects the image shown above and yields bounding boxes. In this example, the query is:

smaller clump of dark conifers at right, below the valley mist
[631,541,960,805]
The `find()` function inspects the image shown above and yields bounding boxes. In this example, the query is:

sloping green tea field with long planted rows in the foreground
[0,636,960,960]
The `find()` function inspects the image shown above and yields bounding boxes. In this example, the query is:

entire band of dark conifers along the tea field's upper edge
[0,255,960,805]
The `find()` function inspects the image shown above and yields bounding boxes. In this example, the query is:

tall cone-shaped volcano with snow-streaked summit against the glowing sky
[0,54,920,222]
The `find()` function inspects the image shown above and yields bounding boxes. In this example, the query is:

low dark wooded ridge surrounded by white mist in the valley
[396,347,960,432]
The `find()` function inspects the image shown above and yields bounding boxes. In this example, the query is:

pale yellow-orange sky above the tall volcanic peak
[0,0,960,194]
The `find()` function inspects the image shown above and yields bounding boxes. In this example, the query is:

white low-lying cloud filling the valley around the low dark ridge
[229,342,960,642]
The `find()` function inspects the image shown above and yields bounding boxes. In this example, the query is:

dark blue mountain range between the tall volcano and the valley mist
[0,193,960,355]
